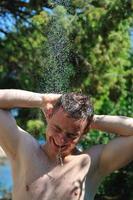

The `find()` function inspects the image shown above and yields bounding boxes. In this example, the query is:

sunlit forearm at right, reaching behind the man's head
[91,115,133,136]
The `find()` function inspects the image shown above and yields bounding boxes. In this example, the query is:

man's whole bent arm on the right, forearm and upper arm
[91,115,133,175]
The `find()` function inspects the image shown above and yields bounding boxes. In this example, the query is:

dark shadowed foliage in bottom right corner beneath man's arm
[98,164,133,200]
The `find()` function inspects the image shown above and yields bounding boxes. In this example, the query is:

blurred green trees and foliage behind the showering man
[0,0,133,200]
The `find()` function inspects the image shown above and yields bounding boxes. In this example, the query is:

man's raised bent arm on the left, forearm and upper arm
[0,89,60,158]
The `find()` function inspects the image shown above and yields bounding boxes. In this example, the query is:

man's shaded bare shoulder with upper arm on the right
[85,136,133,177]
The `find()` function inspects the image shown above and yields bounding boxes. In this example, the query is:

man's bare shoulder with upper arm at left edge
[0,109,37,163]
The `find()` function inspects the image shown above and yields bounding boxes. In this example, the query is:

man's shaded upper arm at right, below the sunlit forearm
[99,136,133,175]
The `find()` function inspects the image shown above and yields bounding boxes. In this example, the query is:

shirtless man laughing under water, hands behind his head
[0,89,133,200]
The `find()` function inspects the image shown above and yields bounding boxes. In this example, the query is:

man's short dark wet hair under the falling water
[53,92,93,124]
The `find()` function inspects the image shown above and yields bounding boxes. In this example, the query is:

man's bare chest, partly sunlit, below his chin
[14,152,90,200]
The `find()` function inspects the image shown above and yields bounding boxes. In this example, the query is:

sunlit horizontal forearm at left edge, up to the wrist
[0,89,43,109]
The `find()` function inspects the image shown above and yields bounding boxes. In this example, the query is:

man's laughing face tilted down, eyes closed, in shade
[46,108,87,156]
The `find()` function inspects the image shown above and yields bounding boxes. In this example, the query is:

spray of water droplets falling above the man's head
[40,0,74,93]
